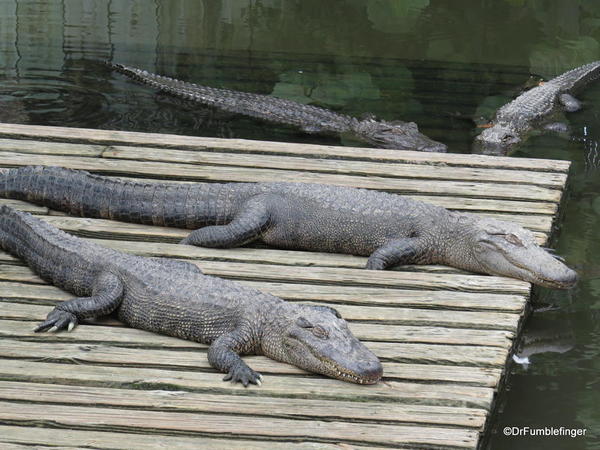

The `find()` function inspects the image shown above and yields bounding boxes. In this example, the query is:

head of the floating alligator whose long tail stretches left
[352,117,447,152]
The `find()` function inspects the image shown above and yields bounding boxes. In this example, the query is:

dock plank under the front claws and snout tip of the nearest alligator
[0,359,493,410]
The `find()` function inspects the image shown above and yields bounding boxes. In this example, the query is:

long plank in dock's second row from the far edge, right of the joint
[103,145,567,189]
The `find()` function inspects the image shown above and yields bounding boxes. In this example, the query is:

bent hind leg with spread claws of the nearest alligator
[34,272,123,332]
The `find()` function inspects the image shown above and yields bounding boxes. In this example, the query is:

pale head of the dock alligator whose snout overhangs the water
[445,214,577,289]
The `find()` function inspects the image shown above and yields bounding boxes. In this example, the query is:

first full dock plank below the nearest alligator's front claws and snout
[0,381,485,430]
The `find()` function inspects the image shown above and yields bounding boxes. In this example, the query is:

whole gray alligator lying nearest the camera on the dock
[0,206,382,386]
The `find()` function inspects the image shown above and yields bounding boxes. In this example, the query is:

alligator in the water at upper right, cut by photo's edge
[474,61,600,155]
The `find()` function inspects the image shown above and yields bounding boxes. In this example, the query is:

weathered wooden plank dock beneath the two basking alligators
[0,124,569,449]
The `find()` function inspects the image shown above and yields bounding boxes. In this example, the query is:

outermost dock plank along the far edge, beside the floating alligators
[0,124,570,173]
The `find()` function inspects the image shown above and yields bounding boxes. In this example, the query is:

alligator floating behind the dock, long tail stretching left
[107,62,447,152]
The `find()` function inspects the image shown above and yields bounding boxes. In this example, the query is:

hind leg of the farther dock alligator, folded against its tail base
[181,195,271,248]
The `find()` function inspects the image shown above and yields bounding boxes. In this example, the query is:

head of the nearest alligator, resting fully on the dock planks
[262,304,383,384]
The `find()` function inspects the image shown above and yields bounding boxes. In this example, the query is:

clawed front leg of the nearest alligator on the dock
[208,331,262,387]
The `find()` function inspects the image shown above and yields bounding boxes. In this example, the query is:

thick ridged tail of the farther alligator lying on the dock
[0,166,244,229]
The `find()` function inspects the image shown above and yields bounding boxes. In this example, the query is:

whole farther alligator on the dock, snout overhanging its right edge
[0,167,577,288]
